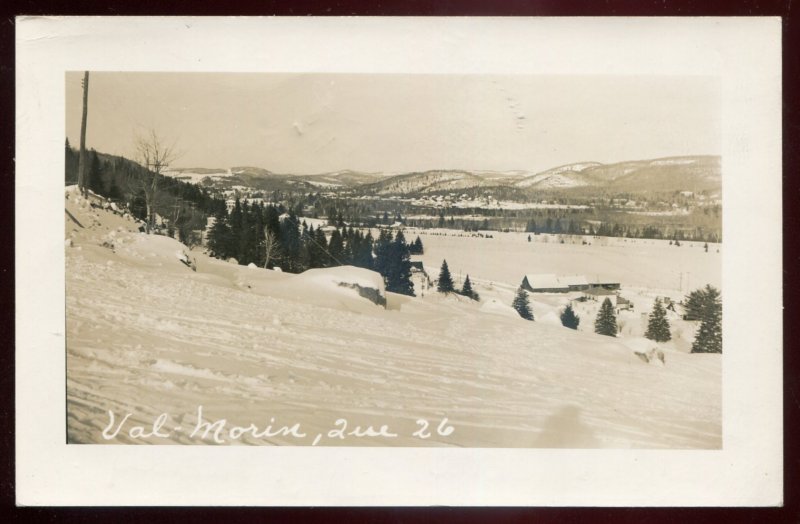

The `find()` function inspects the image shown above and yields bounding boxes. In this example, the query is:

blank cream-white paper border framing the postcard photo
[16,17,783,506]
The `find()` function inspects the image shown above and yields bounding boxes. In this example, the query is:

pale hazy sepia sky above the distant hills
[65,72,721,174]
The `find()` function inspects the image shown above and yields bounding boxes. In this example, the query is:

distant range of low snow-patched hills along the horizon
[169,156,722,196]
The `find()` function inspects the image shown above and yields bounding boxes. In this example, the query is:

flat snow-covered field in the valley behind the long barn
[404,228,722,297]
